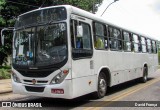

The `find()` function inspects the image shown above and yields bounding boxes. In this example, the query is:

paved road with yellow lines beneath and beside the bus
[0,70,160,110]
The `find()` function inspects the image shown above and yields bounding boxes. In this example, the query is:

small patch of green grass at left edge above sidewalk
[0,66,11,79]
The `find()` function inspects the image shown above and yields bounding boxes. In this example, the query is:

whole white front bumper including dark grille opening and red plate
[12,79,73,99]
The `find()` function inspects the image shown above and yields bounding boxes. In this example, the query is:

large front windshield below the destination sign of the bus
[13,22,67,67]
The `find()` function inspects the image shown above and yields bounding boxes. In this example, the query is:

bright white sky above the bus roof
[96,0,160,41]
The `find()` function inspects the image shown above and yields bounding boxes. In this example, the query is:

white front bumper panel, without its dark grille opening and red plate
[12,79,74,99]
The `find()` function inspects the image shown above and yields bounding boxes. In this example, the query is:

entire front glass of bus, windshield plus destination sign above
[13,7,67,68]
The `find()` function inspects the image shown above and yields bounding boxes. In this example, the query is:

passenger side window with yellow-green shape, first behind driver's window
[93,22,108,49]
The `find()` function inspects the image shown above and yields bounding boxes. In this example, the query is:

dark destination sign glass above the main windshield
[15,7,67,29]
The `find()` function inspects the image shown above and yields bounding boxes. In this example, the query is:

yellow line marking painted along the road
[85,78,160,110]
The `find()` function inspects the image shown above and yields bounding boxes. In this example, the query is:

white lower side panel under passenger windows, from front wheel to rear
[94,50,158,86]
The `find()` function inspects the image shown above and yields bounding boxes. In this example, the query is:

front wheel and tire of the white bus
[93,72,107,99]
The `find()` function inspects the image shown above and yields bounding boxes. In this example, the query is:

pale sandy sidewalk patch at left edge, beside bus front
[0,79,12,94]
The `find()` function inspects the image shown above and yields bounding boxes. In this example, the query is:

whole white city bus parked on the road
[7,5,158,99]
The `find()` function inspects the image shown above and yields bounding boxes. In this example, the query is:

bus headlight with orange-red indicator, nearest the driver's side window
[51,70,69,84]
